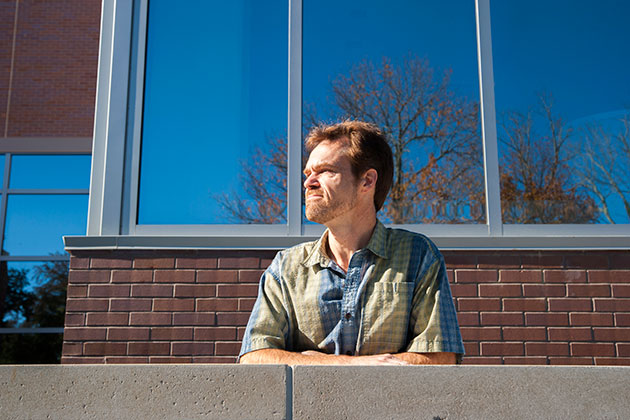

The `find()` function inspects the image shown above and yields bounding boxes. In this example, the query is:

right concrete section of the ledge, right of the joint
[293,366,630,420]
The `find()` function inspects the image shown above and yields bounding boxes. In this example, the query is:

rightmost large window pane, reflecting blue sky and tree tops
[491,0,630,224]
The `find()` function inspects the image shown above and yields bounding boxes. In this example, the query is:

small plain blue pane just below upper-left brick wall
[9,155,91,189]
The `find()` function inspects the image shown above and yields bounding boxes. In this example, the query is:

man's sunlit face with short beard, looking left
[304,141,357,224]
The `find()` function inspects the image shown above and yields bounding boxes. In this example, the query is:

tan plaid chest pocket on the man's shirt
[360,282,414,354]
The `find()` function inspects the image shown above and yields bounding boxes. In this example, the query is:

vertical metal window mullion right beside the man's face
[287,0,302,235]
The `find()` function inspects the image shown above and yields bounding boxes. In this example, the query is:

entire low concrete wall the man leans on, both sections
[0,365,630,420]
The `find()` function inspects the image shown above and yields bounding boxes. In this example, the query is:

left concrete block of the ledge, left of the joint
[0,365,290,420]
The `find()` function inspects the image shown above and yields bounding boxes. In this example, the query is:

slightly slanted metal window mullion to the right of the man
[475,0,503,236]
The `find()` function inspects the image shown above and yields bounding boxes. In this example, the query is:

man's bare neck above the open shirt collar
[326,213,376,271]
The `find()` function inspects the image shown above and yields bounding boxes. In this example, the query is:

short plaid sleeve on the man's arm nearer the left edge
[239,255,289,357]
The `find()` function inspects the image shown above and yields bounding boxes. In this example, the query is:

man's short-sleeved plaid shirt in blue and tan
[240,222,464,356]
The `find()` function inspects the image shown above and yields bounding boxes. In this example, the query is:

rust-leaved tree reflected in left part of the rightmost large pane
[499,95,598,223]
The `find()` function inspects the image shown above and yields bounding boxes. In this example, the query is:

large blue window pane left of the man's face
[138,0,288,224]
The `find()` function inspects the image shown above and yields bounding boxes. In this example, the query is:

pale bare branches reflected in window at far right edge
[578,113,630,223]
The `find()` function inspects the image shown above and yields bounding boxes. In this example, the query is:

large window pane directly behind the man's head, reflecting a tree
[303,0,485,223]
